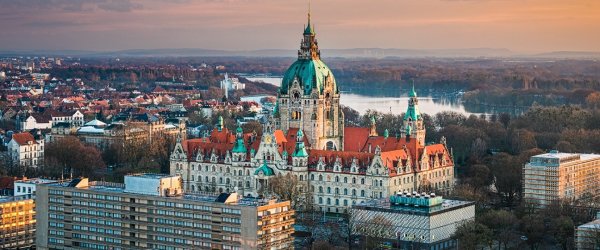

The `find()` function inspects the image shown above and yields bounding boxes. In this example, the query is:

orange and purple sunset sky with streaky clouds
[0,0,600,53]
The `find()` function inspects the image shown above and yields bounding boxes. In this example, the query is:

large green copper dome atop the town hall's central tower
[281,58,337,95]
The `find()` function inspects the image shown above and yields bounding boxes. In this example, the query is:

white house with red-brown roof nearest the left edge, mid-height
[8,132,44,168]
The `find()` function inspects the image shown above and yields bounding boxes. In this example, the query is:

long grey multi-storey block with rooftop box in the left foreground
[36,174,294,249]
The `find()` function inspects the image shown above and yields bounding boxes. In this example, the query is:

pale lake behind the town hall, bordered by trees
[246,76,523,116]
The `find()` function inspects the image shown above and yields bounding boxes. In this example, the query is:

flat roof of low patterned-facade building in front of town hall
[352,199,475,216]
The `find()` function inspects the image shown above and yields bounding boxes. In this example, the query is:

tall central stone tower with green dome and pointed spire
[274,12,344,150]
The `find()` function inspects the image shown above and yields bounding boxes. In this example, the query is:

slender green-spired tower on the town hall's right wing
[402,82,425,146]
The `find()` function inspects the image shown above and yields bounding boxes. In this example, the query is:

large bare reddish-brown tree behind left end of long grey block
[43,136,105,177]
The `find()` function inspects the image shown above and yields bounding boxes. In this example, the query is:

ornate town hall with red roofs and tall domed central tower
[170,14,454,213]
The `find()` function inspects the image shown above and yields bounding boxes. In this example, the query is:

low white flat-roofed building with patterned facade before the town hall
[349,192,475,249]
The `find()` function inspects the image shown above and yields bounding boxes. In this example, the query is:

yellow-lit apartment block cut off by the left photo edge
[0,195,35,249]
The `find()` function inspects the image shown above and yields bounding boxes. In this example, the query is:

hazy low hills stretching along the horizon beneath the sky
[0,48,600,59]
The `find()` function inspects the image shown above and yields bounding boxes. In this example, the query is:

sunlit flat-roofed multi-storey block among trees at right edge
[523,151,600,206]
